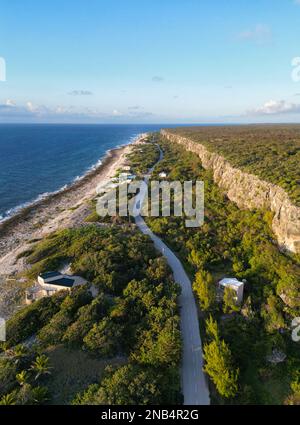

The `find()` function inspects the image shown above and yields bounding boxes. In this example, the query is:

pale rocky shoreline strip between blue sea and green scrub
[0,135,144,277]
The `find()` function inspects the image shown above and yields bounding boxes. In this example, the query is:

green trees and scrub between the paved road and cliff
[146,134,300,404]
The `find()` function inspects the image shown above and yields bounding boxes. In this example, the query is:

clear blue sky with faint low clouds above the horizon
[0,0,300,123]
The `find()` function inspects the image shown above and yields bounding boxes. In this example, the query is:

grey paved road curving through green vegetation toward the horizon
[135,146,210,405]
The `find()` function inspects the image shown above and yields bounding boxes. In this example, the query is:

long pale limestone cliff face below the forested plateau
[161,130,300,253]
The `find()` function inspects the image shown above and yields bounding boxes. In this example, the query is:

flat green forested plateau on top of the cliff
[168,125,300,206]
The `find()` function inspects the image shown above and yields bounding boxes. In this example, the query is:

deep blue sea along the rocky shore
[0,124,163,220]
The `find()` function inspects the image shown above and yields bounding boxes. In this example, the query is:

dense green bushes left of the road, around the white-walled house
[0,225,181,404]
